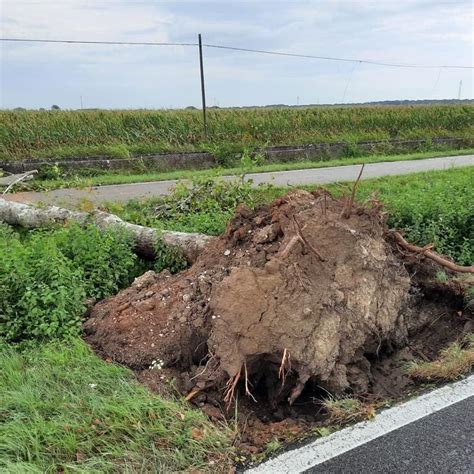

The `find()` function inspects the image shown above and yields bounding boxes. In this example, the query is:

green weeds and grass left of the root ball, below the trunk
[0,225,231,473]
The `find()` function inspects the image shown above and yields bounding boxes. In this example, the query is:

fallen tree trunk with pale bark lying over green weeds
[0,198,215,263]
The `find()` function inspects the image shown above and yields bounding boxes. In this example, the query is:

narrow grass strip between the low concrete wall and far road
[23,148,474,191]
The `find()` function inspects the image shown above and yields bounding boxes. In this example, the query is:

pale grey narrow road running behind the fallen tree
[4,155,474,205]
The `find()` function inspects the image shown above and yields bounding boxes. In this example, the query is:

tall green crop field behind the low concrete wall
[0,105,474,161]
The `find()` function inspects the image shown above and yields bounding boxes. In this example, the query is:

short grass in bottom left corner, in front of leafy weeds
[0,340,230,474]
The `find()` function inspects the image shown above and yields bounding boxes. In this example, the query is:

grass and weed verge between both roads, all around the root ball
[0,167,474,473]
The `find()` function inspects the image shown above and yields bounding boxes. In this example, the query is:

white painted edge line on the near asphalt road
[246,375,474,474]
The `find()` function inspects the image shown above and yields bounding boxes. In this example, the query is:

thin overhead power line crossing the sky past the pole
[0,38,474,69]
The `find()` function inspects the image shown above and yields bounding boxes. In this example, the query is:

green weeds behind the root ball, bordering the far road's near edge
[104,167,474,265]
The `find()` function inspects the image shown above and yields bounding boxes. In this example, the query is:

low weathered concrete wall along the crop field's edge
[0,138,474,173]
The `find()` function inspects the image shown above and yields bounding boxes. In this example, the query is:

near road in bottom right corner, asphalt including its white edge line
[246,375,474,474]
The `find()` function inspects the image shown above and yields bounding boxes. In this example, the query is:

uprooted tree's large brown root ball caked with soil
[85,191,472,414]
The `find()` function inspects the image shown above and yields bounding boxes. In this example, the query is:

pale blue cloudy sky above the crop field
[0,0,474,109]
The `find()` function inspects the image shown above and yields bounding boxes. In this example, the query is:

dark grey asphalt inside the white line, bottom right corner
[305,397,474,474]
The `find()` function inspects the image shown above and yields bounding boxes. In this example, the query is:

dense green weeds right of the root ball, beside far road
[344,166,474,265]
